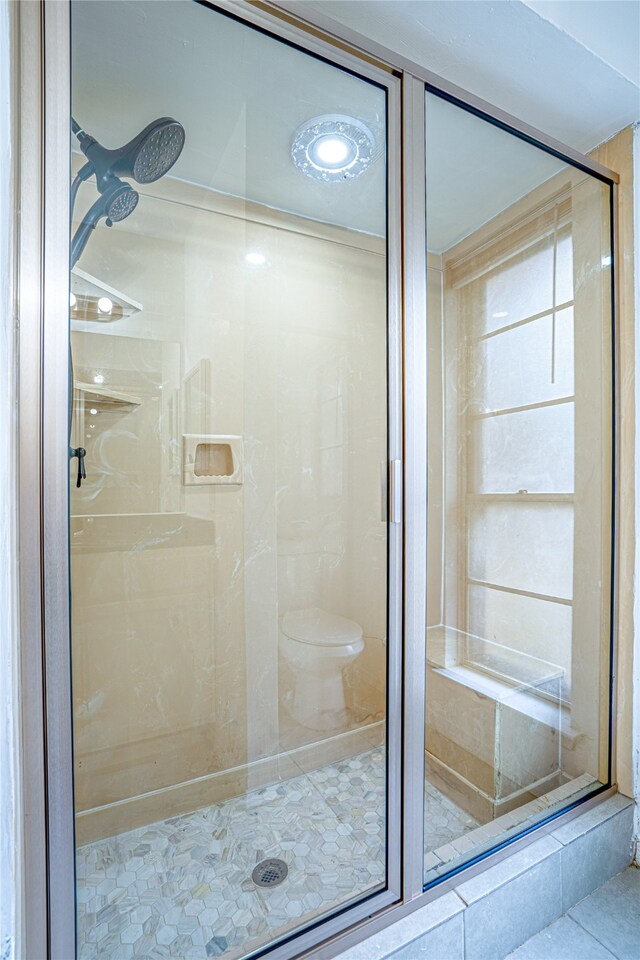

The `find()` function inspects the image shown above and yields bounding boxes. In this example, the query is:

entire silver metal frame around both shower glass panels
[17,0,620,960]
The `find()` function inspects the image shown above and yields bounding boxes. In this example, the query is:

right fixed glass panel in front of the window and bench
[424,94,612,884]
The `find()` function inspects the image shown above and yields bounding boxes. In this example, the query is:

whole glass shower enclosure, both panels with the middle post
[48,0,615,960]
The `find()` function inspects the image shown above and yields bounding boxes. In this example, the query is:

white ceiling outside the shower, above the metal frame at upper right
[302,0,640,152]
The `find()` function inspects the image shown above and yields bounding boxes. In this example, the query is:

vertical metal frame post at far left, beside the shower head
[13,0,75,960]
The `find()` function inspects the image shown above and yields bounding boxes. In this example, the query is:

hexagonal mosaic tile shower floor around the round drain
[77,748,476,960]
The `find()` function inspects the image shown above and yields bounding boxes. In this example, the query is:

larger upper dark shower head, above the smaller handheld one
[74,117,185,193]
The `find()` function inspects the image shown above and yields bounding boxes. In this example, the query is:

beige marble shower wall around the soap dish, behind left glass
[71,181,386,835]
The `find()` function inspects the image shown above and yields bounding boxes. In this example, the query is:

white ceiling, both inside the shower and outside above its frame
[72,0,640,251]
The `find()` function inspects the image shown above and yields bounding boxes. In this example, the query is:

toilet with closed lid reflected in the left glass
[280,607,364,730]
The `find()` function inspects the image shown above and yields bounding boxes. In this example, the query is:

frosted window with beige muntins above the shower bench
[459,196,575,701]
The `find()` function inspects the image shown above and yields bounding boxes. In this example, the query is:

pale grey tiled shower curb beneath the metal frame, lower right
[332,794,635,960]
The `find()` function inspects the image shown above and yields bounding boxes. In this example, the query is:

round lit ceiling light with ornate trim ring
[291,113,376,183]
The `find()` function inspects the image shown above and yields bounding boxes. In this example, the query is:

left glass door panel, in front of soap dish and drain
[71,0,388,960]
